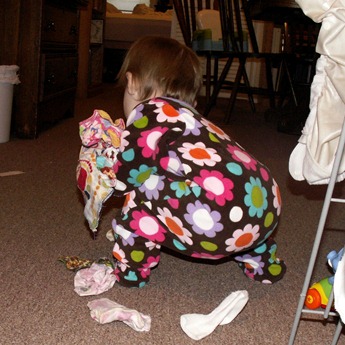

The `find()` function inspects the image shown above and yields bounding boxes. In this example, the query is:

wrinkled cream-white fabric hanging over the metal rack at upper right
[289,0,345,184]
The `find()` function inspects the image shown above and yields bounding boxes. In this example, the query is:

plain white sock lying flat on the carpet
[180,290,248,340]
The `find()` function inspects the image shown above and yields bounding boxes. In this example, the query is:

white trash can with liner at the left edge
[0,65,20,143]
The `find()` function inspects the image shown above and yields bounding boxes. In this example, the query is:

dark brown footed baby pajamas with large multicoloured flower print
[113,98,286,287]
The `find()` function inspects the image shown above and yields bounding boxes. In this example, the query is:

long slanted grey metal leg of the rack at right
[288,117,345,345]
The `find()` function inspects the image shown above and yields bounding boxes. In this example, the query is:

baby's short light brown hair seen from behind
[118,36,202,105]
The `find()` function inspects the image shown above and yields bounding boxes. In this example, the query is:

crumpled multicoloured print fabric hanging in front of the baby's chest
[76,110,125,233]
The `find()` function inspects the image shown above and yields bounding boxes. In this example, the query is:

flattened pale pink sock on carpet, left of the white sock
[87,298,151,332]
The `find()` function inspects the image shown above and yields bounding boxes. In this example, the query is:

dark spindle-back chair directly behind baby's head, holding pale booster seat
[173,0,218,103]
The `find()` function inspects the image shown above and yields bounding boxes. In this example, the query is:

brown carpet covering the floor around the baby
[0,85,345,345]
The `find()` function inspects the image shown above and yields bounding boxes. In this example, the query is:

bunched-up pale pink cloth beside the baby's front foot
[74,263,116,296]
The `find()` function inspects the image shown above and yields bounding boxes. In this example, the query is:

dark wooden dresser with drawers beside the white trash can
[13,0,88,138]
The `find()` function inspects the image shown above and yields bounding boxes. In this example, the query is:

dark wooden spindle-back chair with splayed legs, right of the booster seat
[204,0,296,122]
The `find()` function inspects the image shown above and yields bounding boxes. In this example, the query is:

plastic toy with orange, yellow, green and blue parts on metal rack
[305,248,344,309]
